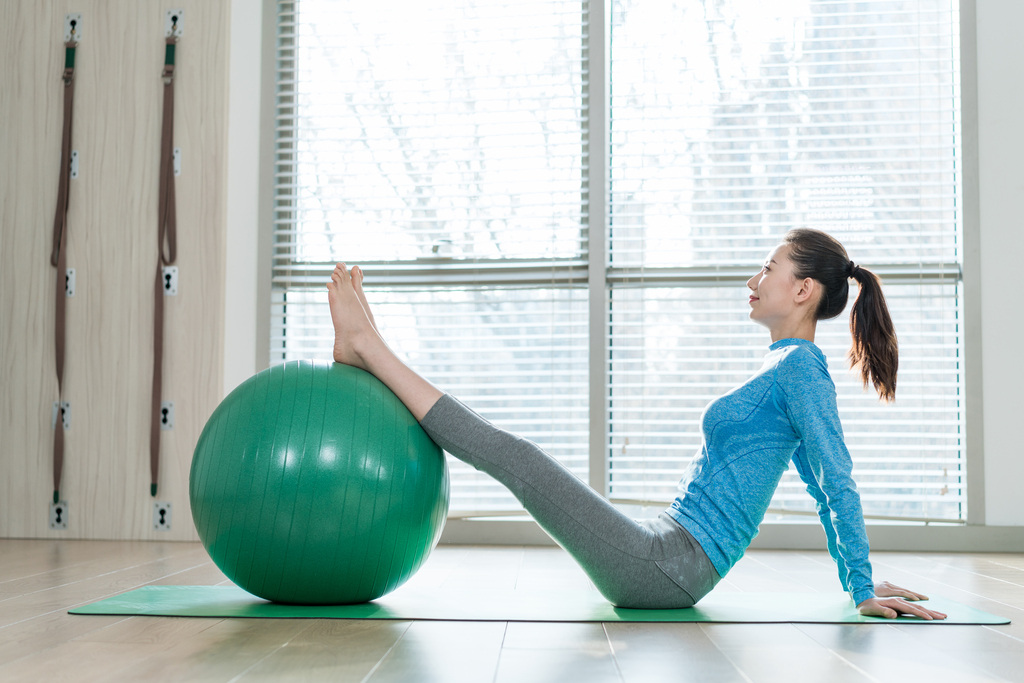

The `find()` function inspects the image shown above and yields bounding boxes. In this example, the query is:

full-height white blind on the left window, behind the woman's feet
[271,0,588,513]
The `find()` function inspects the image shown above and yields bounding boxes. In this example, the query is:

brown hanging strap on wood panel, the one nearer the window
[150,36,178,497]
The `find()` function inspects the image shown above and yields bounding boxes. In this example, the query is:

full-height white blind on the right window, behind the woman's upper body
[607,0,966,521]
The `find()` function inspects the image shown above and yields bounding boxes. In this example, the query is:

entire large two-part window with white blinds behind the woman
[271,0,966,521]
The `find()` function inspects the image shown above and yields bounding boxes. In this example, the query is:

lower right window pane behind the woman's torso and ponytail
[608,284,966,519]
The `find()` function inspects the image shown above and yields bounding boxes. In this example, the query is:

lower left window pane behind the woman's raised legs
[271,289,588,510]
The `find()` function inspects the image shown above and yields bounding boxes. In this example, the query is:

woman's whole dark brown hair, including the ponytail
[782,228,899,401]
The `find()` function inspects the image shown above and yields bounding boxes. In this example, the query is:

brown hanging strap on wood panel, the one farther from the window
[50,40,78,503]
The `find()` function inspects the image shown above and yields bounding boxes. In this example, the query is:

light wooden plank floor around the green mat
[0,540,1024,683]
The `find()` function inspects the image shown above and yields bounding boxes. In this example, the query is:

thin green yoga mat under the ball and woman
[70,586,1010,624]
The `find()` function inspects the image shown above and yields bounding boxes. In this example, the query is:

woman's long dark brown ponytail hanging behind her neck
[849,261,899,401]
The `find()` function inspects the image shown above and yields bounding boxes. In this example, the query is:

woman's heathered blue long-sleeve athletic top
[669,339,874,604]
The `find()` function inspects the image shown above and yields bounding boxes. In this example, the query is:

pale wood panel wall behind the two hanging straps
[0,0,228,540]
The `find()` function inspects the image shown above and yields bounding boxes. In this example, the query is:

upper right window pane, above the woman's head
[609,0,961,266]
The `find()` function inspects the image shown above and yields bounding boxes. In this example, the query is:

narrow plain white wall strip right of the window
[977,0,1024,525]
